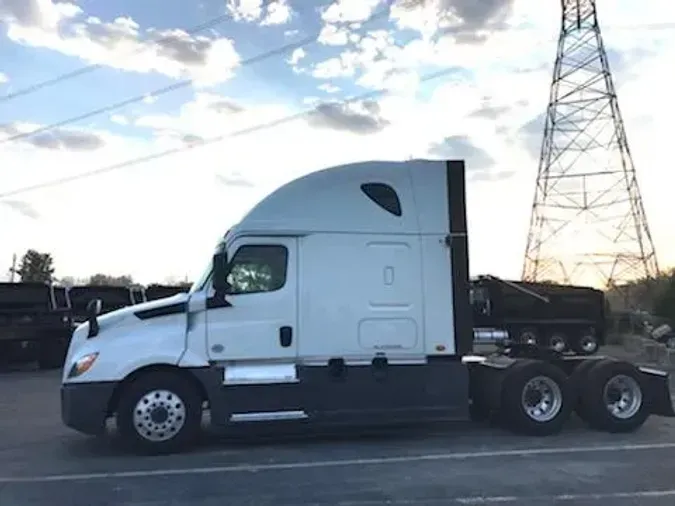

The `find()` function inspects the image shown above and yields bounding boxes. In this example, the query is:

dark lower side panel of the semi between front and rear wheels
[193,359,469,428]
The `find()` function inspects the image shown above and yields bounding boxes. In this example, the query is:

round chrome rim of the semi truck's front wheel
[134,390,185,443]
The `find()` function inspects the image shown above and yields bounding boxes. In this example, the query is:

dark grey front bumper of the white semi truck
[61,382,117,435]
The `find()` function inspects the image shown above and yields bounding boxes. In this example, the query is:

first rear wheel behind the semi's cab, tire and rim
[501,360,573,436]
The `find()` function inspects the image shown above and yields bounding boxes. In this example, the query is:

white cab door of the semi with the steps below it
[206,237,306,424]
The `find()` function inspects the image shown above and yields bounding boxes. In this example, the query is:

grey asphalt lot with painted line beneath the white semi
[0,371,675,506]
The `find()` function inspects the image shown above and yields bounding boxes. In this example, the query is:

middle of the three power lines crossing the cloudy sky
[0,8,389,144]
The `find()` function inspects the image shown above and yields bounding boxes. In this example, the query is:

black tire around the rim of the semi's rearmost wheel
[581,360,649,433]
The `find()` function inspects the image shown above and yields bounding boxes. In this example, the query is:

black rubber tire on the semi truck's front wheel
[116,371,202,455]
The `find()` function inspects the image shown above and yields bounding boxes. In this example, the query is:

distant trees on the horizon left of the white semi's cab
[13,249,190,287]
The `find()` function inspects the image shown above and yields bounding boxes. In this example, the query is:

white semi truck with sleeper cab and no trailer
[61,160,675,453]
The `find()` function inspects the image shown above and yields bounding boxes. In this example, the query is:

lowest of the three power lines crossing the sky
[0,66,458,199]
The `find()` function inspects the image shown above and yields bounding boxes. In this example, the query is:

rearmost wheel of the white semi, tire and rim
[581,360,649,432]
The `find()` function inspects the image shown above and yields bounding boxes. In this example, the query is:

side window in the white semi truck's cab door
[227,244,288,295]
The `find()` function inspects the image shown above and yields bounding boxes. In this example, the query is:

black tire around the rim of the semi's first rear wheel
[500,360,574,436]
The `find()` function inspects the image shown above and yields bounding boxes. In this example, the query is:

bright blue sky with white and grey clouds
[0,0,675,283]
